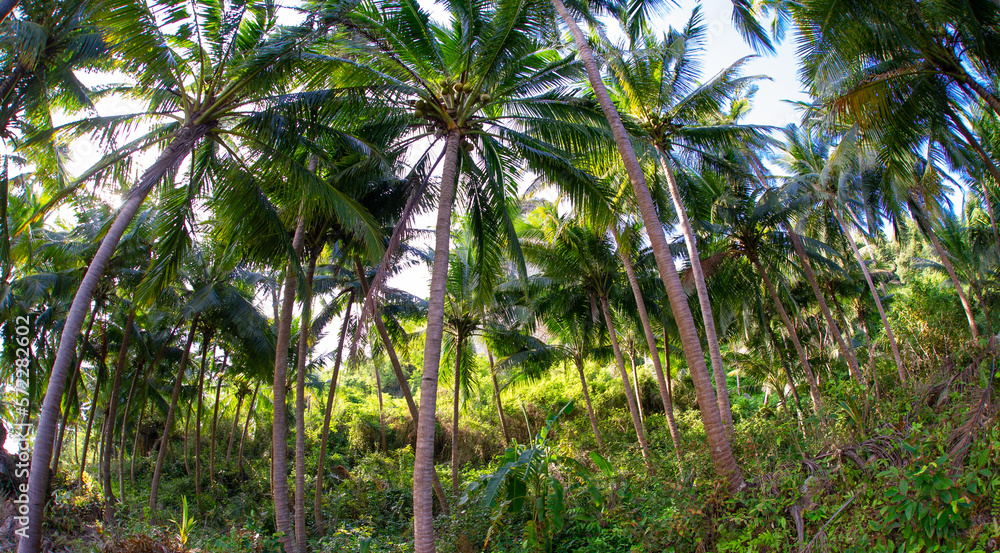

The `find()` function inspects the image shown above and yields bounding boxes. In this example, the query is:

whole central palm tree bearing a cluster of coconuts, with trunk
[336,0,597,553]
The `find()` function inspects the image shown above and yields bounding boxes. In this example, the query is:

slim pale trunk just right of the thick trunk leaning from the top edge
[656,154,733,436]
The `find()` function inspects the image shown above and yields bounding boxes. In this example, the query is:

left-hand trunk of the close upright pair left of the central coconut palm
[271,199,305,553]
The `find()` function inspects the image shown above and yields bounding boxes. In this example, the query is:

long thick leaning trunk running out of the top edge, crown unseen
[552,0,744,491]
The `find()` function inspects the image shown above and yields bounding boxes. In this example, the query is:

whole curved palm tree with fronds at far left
[18,2,370,553]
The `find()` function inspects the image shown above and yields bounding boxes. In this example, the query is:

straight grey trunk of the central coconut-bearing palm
[413,128,462,553]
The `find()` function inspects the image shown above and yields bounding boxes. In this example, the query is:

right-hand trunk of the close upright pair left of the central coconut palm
[295,250,323,553]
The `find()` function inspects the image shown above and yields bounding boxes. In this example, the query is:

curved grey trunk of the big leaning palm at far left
[17,125,210,553]
